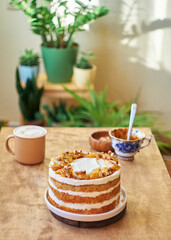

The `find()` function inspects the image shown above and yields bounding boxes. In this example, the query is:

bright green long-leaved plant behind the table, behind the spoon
[64,87,156,127]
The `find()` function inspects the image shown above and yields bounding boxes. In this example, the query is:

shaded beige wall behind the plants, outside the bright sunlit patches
[0,0,171,128]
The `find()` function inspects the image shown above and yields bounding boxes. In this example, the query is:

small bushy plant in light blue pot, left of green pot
[19,49,39,83]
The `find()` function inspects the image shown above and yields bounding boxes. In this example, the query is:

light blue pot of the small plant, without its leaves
[19,65,39,83]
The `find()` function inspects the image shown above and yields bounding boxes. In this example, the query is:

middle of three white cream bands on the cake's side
[49,178,120,197]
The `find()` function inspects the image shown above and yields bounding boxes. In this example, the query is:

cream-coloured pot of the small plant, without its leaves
[73,65,97,87]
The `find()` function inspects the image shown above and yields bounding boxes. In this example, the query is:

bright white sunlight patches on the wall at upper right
[121,0,168,70]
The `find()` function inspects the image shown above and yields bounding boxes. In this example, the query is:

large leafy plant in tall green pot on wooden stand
[9,0,109,83]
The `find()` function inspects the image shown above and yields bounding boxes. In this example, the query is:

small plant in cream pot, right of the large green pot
[74,52,96,87]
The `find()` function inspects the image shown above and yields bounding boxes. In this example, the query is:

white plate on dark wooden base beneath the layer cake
[44,186,127,228]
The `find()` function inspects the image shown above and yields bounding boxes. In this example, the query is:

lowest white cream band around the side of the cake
[48,188,120,210]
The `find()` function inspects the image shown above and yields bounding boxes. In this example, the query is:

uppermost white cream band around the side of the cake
[49,168,121,186]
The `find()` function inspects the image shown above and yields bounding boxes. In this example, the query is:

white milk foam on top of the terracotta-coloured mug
[14,125,47,138]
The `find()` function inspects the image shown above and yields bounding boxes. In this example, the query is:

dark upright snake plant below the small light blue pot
[16,69,44,121]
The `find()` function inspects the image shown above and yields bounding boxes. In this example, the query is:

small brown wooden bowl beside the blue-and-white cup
[89,131,113,152]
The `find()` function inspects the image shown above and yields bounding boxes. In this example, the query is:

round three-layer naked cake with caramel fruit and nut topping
[47,151,120,214]
